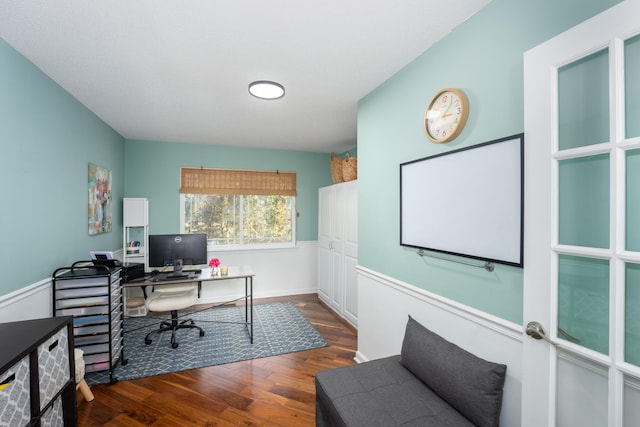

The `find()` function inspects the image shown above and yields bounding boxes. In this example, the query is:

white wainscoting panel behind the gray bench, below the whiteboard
[356,267,523,427]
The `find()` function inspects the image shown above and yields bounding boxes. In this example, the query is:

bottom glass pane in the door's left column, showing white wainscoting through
[556,351,609,427]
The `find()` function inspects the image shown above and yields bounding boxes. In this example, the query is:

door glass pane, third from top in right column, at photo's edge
[624,264,640,366]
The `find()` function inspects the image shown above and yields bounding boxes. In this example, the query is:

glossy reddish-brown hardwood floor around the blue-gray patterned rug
[78,294,357,427]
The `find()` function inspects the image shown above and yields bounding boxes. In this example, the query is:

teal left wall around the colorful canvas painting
[0,39,124,295]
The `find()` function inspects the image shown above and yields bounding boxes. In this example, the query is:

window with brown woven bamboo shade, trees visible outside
[180,168,296,249]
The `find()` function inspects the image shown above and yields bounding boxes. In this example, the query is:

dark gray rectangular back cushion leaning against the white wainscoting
[400,316,507,427]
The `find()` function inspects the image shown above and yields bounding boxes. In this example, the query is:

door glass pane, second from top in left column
[558,154,609,248]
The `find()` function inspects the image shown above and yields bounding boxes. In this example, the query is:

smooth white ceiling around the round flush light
[0,0,490,153]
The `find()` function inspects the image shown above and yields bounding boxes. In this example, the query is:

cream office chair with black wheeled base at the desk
[144,283,204,348]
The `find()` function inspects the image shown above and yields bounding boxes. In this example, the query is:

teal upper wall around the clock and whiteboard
[358,0,618,323]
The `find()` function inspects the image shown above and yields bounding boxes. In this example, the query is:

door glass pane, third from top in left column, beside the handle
[558,255,609,354]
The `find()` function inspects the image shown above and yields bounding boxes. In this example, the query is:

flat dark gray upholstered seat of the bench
[316,355,473,427]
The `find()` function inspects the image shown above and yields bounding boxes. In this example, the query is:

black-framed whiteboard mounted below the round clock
[400,134,524,267]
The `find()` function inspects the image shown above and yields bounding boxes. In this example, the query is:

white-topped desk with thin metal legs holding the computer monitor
[123,265,255,344]
